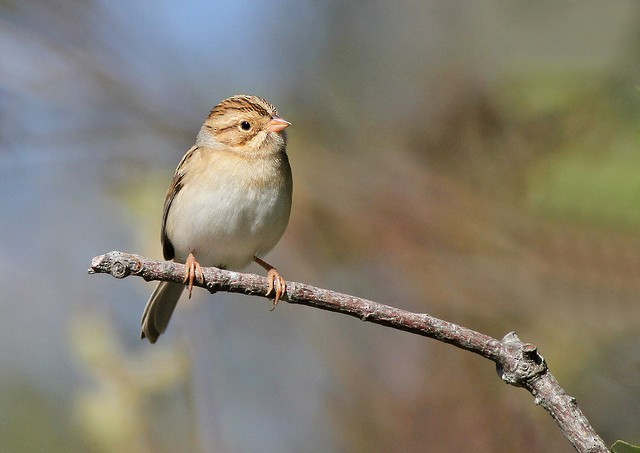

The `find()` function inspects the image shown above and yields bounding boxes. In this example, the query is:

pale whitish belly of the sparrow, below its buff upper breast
[167,182,291,269]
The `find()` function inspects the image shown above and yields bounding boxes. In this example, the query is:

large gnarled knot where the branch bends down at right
[496,332,547,387]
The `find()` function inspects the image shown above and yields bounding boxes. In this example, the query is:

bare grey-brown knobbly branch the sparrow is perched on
[89,252,609,453]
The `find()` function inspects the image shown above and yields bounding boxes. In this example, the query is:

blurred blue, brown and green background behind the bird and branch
[0,0,640,452]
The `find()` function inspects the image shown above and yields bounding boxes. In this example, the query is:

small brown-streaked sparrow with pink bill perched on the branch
[141,94,293,343]
